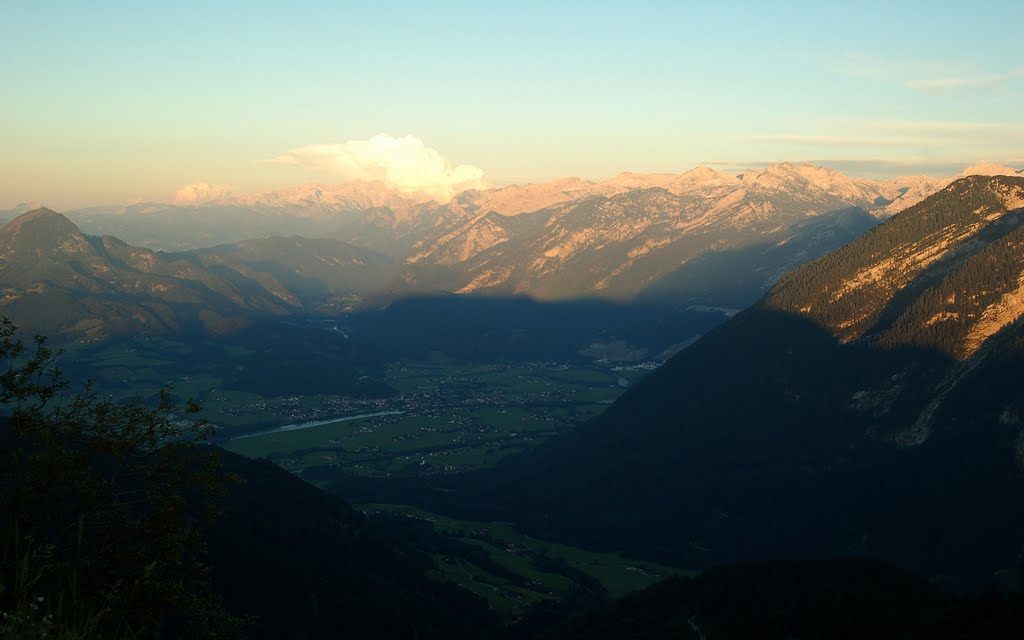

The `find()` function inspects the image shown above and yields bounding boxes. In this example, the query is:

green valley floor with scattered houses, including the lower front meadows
[213,357,680,620]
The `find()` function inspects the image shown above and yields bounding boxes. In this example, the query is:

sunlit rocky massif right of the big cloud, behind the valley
[408,165,901,302]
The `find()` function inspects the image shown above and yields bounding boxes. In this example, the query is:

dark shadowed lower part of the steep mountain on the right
[323,307,1024,583]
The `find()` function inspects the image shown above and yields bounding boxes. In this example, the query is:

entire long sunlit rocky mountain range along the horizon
[59,163,1016,303]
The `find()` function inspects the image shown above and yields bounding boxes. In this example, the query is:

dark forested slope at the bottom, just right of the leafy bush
[209,452,502,639]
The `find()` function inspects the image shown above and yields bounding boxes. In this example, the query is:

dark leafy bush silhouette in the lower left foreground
[0,317,241,639]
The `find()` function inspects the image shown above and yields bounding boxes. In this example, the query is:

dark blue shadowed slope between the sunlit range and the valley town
[338,295,727,362]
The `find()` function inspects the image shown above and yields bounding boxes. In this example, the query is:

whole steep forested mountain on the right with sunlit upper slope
[459,177,1024,582]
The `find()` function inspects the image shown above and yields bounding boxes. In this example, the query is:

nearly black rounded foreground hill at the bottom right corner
[542,558,1024,640]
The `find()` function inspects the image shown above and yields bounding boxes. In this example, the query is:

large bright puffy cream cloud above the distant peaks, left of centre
[273,133,483,202]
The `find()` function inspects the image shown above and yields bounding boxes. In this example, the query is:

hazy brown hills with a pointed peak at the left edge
[0,209,394,340]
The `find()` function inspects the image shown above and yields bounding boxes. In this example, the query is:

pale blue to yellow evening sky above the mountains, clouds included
[0,0,1024,209]
